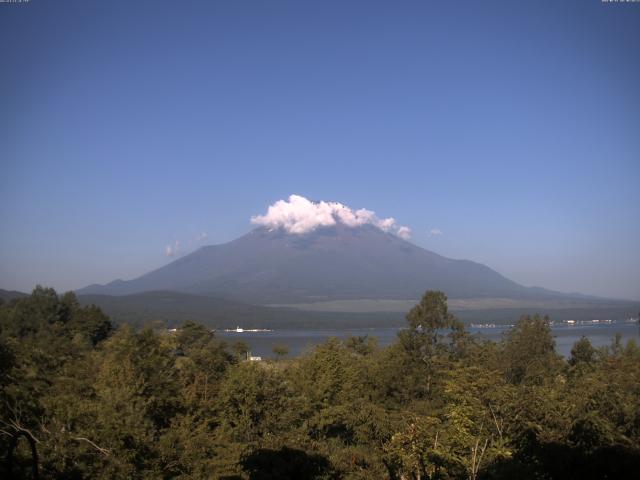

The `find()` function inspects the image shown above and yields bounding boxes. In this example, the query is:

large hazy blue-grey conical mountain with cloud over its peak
[77,223,584,304]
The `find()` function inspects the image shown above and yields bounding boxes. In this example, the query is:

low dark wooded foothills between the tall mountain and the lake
[78,291,639,329]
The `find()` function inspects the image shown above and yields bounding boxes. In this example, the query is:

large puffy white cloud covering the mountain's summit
[251,195,411,239]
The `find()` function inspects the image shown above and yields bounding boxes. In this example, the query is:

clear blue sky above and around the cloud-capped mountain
[0,0,640,299]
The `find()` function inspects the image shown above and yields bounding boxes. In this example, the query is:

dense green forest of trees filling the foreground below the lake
[0,287,640,480]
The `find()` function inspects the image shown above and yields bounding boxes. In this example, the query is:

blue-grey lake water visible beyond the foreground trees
[216,322,640,358]
